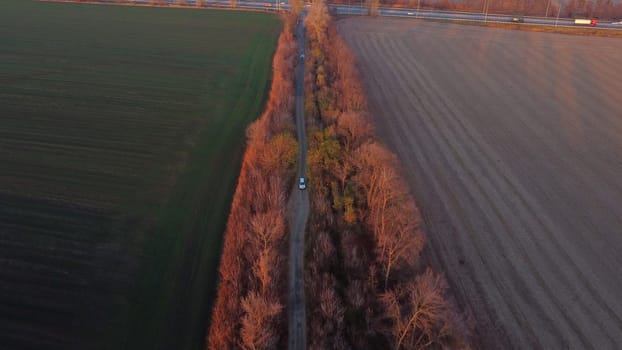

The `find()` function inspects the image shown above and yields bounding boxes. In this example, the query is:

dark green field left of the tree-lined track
[0,0,281,349]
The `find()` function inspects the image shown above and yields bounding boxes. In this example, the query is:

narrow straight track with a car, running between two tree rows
[287,16,309,350]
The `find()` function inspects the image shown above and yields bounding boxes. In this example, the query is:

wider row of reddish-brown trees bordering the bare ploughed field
[305,0,470,349]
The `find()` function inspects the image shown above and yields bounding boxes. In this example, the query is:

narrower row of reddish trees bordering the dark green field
[207,17,298,350]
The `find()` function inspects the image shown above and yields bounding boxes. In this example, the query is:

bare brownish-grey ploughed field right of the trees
[339,18,622,349]
